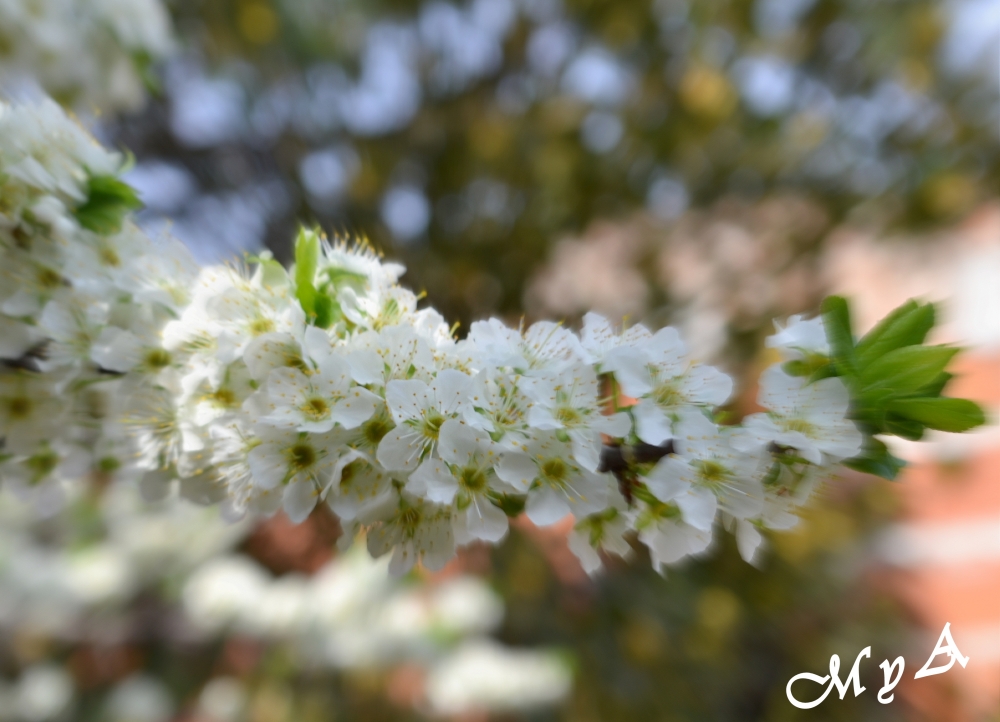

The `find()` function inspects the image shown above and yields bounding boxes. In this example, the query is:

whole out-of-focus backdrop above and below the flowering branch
[0,0,1000,722]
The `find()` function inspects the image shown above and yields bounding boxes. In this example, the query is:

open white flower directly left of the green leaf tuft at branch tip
[733,365,862,465]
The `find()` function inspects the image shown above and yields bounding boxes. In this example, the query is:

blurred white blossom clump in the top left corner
[0,0,174,112]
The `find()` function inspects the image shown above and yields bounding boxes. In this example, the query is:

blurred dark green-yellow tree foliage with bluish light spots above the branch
[116,0,1000,324]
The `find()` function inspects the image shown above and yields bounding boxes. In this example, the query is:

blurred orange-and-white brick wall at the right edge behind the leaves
[825,206,1000,722]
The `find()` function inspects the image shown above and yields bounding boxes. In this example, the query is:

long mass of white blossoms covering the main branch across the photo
[0,97,862,574]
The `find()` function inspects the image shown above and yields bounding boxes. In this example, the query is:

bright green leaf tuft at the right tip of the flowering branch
[820,296,986,479]
